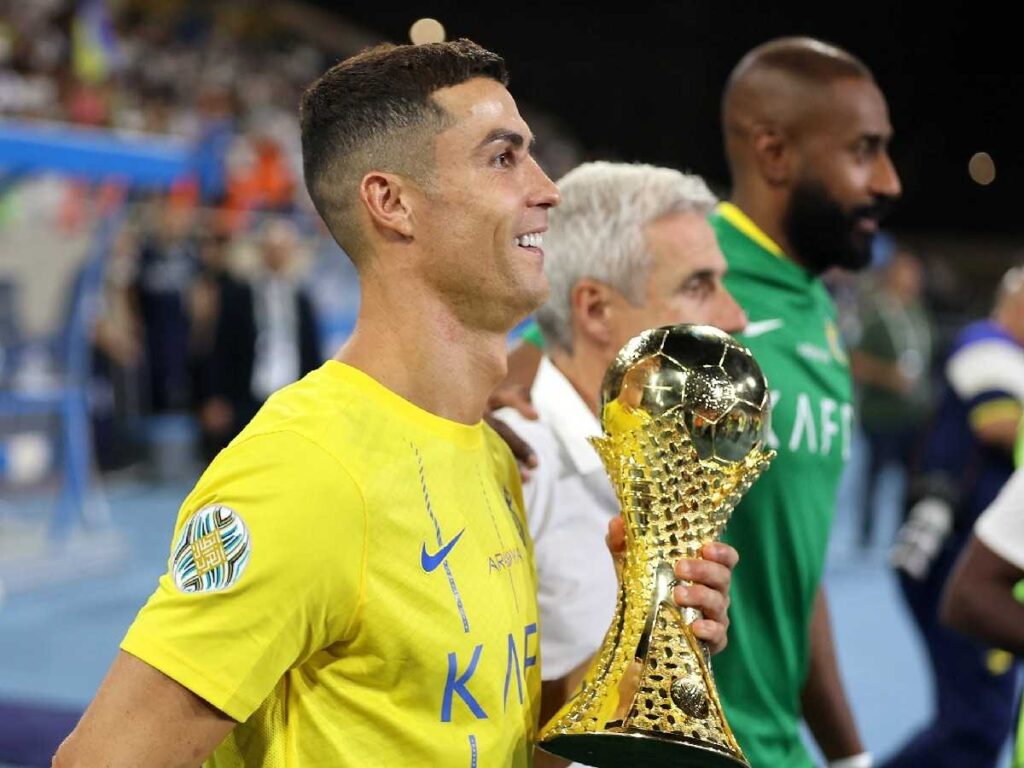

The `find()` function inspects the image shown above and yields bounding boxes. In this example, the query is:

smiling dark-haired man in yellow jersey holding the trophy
[54,40,729,768]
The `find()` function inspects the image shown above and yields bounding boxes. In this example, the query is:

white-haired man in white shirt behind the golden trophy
[502,163,745,766]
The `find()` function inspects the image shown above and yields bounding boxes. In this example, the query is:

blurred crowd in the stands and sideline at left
[0,0,581,481]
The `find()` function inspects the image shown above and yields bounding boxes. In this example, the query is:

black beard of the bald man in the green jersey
[782,181,891,274]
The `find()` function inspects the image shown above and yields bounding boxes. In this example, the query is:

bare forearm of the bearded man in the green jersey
[800,588,864,760]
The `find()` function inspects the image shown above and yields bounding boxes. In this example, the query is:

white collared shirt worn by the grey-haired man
[497,357,618,680]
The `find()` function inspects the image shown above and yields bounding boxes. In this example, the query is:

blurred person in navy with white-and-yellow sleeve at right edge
[886,267,1024,768]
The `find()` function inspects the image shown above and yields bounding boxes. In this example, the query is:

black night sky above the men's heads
[324,0,1024,234]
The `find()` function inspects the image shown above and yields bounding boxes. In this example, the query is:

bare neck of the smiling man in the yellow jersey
[335,275,507,424]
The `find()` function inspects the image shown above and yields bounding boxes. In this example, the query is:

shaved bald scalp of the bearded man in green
[722,37,873,175]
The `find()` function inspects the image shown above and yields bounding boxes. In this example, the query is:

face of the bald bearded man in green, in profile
[783,78,900,272]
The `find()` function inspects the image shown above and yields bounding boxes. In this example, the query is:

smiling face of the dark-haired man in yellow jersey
[414,78,559,333]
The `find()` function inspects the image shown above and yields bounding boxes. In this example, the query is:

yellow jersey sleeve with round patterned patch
[121,432,367,722]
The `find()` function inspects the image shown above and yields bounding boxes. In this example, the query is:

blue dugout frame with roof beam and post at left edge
[0,120,195,591]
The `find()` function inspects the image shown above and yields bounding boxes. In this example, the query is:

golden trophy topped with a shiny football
[540,325,774,768]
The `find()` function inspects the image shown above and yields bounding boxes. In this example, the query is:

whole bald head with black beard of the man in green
[722,38,900,273]
